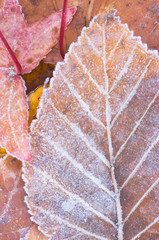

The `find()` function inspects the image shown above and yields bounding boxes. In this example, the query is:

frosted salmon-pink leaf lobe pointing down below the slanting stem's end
[0,70,31,160]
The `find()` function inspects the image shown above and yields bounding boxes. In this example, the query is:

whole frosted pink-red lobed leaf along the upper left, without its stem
[0,0,76,161]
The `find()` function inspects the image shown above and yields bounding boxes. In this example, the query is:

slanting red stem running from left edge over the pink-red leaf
[0,31,22,74]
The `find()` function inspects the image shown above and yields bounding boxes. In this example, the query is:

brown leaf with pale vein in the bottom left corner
[0,155,33,240]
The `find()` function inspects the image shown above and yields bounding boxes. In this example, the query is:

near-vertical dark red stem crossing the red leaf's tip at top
[60,0,68,58]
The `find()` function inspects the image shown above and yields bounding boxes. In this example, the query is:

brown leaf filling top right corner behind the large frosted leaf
[100,0,159,50]
